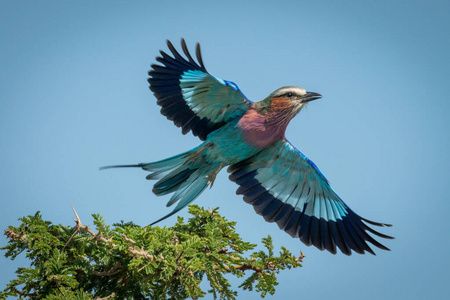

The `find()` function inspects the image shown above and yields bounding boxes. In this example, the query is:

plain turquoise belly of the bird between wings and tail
[205,122,261,165]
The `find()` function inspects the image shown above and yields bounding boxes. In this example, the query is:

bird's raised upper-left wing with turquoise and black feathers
[148,39,251,140]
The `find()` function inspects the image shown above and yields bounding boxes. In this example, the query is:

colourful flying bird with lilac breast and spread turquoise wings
[102,39,393,255]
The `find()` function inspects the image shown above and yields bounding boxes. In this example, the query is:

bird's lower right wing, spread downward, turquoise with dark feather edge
[228,139,392,255]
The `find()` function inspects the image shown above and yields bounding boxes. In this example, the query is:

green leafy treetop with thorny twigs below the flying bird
[0,205,303,300]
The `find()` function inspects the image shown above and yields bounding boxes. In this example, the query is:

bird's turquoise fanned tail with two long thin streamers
[100,147,222,225]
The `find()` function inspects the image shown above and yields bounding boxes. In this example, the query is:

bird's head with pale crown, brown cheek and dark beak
[255,86,322,118]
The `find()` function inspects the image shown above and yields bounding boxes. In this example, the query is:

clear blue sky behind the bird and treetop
[0,0,450,299]
